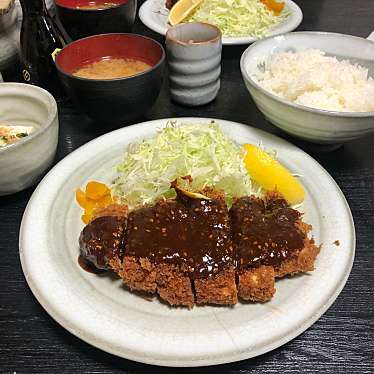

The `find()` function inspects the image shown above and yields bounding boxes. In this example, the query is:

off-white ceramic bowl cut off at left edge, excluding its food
[0,83,58,196]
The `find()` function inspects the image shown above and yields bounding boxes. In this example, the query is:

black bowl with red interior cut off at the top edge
[55,0,137,40]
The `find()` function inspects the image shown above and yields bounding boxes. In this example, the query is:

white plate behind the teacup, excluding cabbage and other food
[139,0,303,45]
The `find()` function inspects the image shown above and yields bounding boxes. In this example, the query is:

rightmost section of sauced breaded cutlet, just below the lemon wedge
[230,193,319,302]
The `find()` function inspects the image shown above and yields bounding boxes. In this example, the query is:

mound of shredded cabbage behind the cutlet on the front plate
[112,122,258,208]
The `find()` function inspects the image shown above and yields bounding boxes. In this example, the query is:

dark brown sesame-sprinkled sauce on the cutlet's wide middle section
[125,196,234,279]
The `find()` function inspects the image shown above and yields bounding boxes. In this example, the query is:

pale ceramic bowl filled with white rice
[240,32,374,144]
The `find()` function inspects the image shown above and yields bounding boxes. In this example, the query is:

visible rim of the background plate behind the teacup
[139,0,303,45]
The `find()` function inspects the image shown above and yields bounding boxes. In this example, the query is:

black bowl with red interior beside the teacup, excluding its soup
[56,34,165,122]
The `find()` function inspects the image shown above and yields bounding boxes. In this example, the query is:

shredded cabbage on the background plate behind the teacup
[186,0,289,38]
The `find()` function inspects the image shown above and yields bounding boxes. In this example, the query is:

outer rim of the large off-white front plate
[19,117,355,367]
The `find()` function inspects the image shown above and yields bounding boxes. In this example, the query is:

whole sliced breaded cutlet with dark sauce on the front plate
[80,186,319,308]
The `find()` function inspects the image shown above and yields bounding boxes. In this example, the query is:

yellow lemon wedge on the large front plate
[244,144,305,205]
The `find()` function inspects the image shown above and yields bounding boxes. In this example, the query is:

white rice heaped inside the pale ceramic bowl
[253,49,374,112]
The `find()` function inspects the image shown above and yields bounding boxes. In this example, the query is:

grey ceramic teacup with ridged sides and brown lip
[166,22,222,106]
